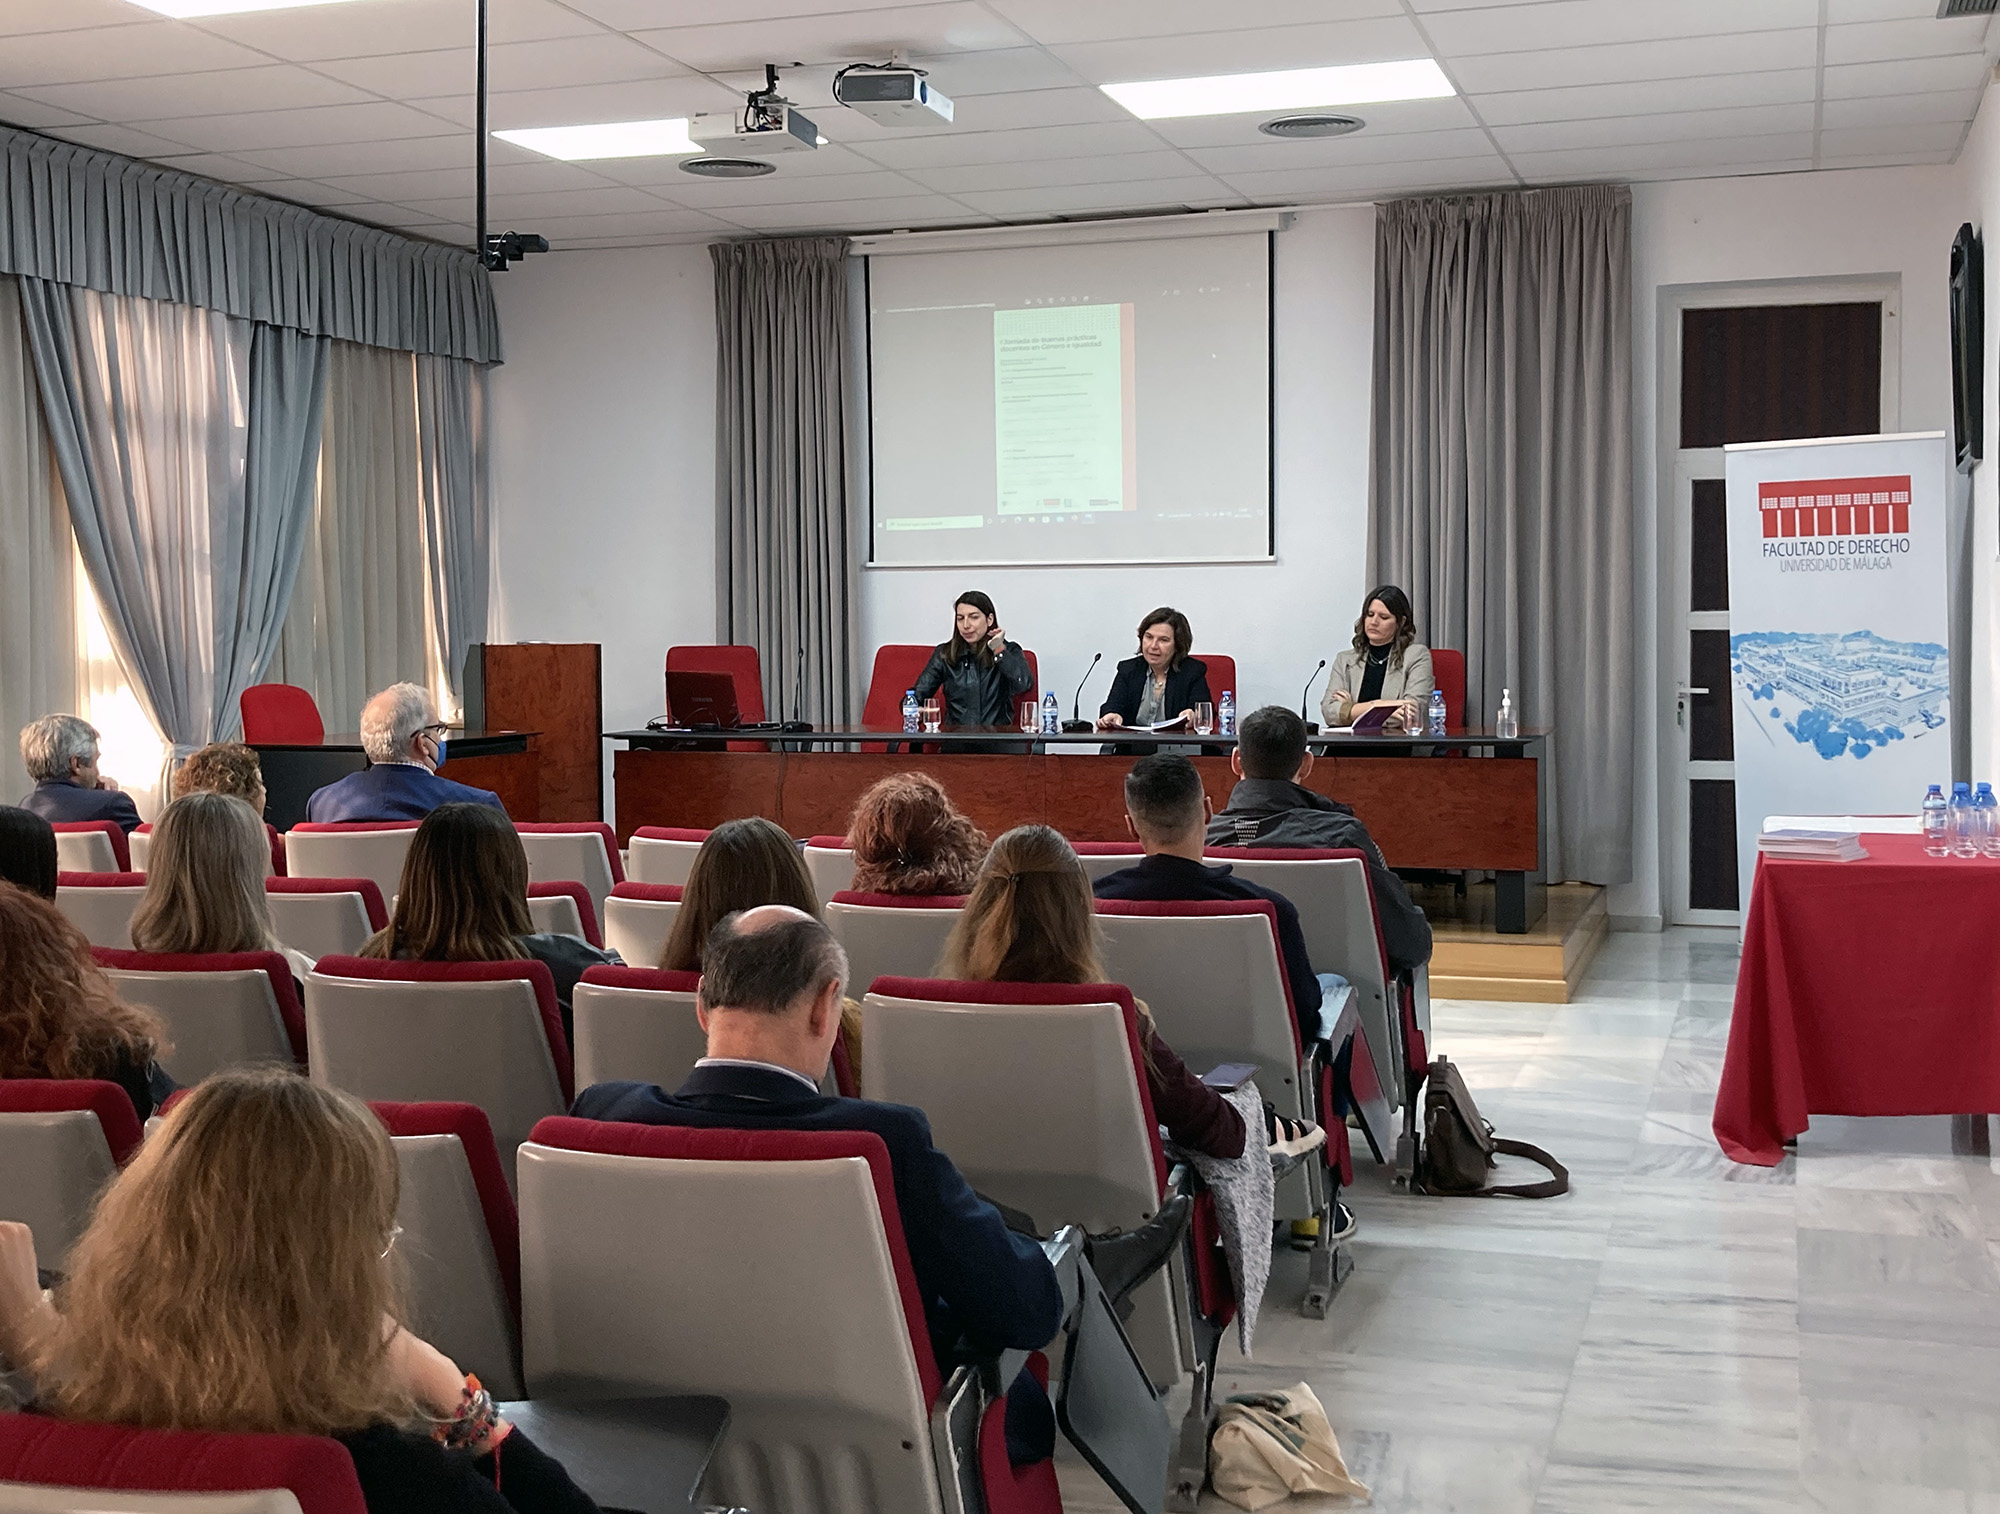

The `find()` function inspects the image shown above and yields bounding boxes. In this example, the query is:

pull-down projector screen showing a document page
[868,232,1272,566]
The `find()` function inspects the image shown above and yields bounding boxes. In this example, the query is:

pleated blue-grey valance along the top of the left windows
[0,126,500,362]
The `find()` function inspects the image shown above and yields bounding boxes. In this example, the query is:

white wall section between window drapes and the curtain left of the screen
[490,246,716,812]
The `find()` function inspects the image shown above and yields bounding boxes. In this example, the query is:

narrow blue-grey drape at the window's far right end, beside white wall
[416,356,492,698]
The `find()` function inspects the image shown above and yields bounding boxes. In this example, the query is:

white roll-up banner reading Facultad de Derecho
[1722,432,1952,908]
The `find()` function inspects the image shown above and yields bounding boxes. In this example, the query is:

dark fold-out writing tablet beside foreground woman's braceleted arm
[500,1394,730,1514]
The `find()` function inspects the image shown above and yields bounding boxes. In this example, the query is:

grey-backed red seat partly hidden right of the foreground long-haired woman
[368,1102,524,1398]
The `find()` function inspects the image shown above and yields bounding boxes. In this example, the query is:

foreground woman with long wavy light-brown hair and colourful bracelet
[0,1070,596,1514]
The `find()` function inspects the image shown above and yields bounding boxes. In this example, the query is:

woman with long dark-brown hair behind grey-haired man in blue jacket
[362,804,624,1036]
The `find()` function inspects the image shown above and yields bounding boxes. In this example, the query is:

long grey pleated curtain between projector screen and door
[1368,186,1634,884]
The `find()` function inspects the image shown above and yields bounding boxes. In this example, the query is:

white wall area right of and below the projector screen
[858,206,1376,718]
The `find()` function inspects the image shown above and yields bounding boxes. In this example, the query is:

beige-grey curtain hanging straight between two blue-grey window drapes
[266,342,430,730]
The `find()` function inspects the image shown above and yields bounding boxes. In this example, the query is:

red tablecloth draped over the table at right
[1714,834,2000,1166]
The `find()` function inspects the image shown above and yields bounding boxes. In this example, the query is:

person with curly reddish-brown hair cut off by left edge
[0,884,176,1120]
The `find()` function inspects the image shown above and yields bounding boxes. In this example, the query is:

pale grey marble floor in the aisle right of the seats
[1058,930,2000,1514]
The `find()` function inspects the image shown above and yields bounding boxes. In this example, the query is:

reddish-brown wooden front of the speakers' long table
[614,752,1540,872]
